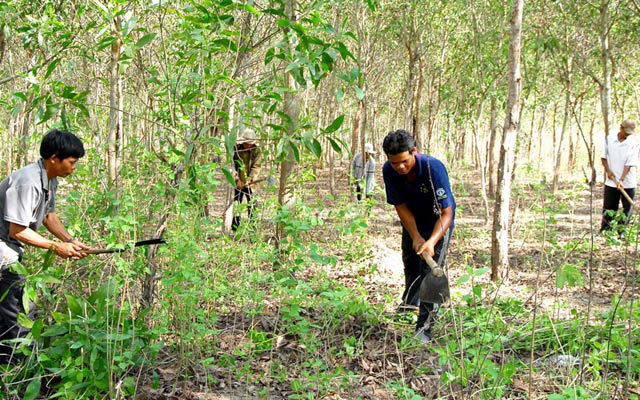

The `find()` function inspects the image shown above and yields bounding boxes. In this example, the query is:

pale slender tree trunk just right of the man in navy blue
[491,0,524,281]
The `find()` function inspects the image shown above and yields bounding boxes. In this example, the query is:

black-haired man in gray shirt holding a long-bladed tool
[0,129,88,364]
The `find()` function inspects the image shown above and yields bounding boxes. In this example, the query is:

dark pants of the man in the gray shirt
[0,268,35,364]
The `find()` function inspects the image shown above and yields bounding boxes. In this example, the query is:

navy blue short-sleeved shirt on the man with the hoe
[382,153,456,233]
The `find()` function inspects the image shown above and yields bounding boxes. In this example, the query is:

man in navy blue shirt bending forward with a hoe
[382,129,456,342]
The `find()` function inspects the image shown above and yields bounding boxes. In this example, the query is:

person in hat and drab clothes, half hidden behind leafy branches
[231,128,261,231]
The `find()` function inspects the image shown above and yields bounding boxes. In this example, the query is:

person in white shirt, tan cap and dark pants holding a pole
[600,119,638,232]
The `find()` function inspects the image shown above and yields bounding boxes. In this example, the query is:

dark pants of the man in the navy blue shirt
[402,226,453,331]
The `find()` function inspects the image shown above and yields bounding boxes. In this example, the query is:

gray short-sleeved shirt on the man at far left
[0,160,58,266]
